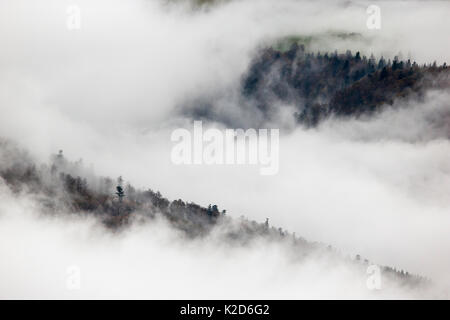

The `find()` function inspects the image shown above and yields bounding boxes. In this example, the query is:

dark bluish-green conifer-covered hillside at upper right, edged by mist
[241,43,450,126]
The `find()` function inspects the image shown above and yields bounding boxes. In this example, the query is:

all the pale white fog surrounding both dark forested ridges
[0,0,450,298]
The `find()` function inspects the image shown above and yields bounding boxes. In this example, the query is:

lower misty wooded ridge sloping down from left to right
[0,140,429,287]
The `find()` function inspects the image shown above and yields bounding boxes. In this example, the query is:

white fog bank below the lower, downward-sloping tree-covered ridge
[0,183,443,299]
